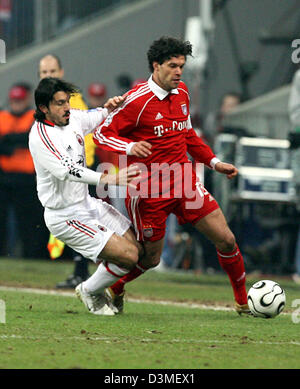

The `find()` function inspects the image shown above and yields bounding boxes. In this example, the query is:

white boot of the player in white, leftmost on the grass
[75,283,114,316]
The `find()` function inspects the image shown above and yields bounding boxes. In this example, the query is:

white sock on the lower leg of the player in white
[83,261,129,294]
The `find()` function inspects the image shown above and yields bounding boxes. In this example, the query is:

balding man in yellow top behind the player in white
[38,54,95,289]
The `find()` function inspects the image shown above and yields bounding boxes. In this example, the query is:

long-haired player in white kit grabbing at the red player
[29,78,142,315]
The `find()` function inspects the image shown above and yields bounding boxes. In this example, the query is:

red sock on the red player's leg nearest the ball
[217,245,247,305]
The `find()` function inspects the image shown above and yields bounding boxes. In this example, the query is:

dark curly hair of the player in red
[147,36,192,72]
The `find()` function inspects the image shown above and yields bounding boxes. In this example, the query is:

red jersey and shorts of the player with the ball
[94,77,218,241]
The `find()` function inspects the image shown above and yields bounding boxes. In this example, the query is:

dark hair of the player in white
[34,77,79,121]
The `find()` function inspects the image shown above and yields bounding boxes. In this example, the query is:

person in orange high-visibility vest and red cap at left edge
[0,83,48,258]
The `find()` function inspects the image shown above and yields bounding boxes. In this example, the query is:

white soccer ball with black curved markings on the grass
[248,280,286,319]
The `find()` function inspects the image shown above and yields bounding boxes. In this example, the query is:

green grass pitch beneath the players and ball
[0,258,300,369]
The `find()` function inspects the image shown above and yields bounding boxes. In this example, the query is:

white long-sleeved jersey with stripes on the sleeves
[29,108,108,210]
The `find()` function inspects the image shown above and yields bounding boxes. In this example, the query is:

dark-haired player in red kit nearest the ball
[94,37,249,313]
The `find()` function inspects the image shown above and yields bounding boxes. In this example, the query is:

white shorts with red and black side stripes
[44,196,131,262]
